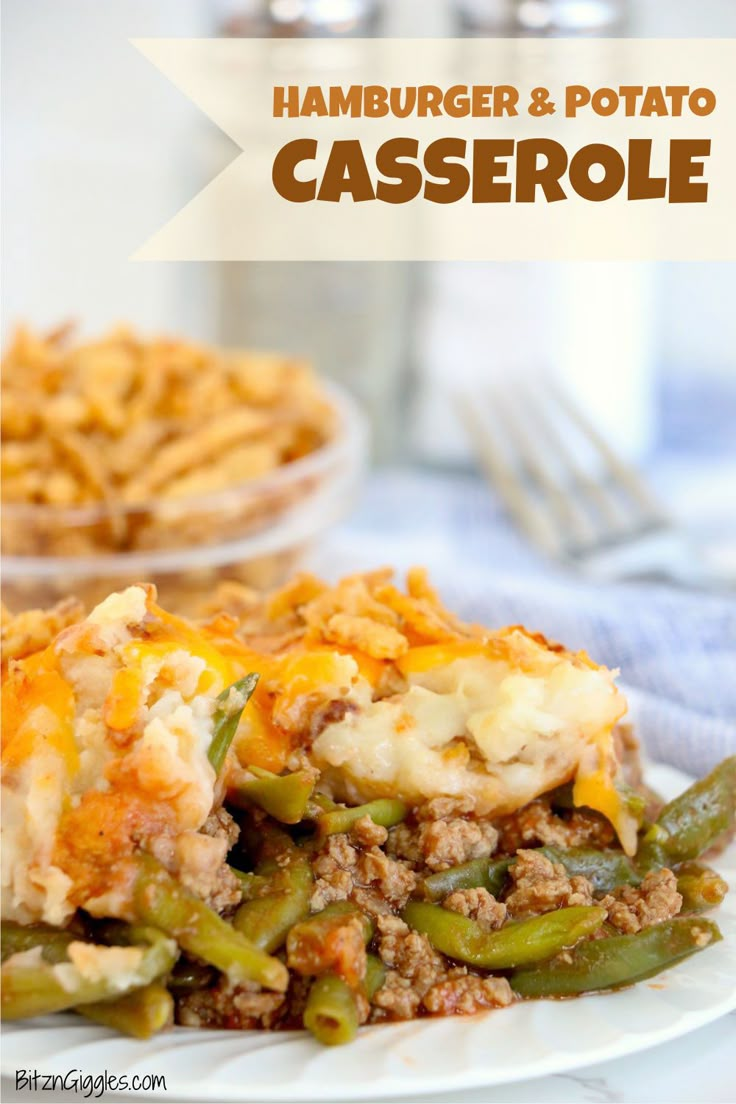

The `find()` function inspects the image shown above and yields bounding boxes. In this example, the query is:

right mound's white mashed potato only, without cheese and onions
[312,630,625,815]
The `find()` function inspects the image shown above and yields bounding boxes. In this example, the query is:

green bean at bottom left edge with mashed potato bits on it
[2,928,178,1020]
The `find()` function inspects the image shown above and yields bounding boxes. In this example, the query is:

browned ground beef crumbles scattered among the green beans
[177,719,682,1029]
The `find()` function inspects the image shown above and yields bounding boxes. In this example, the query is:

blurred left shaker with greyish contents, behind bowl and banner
[211,0,410,460]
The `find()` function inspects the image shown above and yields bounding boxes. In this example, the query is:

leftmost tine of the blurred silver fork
[456,392,563,559]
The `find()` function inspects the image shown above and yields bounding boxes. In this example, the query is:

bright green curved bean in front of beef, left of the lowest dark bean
[402,901,606,969]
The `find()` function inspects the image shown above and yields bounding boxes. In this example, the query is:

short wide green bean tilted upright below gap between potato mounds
[233,854,313,954]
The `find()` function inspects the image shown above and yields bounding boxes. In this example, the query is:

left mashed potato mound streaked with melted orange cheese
[2,586,235,924]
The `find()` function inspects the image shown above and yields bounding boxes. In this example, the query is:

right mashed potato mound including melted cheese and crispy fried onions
[211,569,637,852]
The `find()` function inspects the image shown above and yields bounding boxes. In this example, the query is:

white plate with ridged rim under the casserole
[1,766,736,1102]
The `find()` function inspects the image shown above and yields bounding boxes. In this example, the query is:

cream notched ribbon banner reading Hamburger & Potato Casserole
[135,39,736,261]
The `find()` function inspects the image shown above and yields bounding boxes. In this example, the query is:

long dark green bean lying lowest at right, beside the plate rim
[511,917,722,997]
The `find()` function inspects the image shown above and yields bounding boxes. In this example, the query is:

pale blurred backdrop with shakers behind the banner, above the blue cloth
[2,0,736,452]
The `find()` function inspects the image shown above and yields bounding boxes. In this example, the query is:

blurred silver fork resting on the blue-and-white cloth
[458,376,713,586]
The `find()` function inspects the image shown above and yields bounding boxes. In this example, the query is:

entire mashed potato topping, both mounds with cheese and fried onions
[2,571,637,924]
